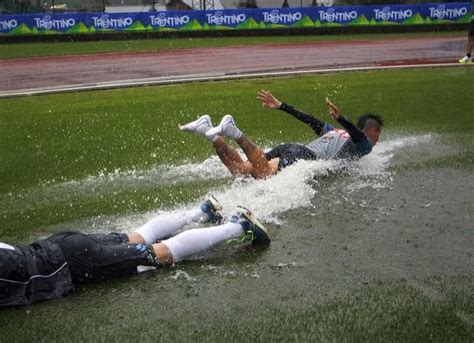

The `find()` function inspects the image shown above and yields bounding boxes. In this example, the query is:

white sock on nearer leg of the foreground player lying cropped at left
[161,223,244,263]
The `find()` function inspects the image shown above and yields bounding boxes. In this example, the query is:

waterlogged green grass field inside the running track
[0,68,474,342]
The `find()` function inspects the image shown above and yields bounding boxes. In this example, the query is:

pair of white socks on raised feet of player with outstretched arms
[179,114,242,141]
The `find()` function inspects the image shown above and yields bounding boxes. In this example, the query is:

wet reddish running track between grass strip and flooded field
[0,35,466,97]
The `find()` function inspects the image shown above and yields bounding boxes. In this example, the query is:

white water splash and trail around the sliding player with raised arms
[0,135,439,231]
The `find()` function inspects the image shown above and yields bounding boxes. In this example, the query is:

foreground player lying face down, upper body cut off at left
[0,197,270,307]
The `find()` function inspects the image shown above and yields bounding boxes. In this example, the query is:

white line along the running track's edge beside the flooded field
[0,63,466,99]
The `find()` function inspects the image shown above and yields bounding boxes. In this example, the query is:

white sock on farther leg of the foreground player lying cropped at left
[135,207,209,244]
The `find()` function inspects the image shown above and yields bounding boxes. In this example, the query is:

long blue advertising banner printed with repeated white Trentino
[0,2,471,35]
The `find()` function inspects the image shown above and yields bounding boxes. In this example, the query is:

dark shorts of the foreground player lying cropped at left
[49,232,158,284]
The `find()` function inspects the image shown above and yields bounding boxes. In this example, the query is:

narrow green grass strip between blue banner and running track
[0,32,465,59]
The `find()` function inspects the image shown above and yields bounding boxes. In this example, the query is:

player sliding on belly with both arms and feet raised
[180,90,383,179]
